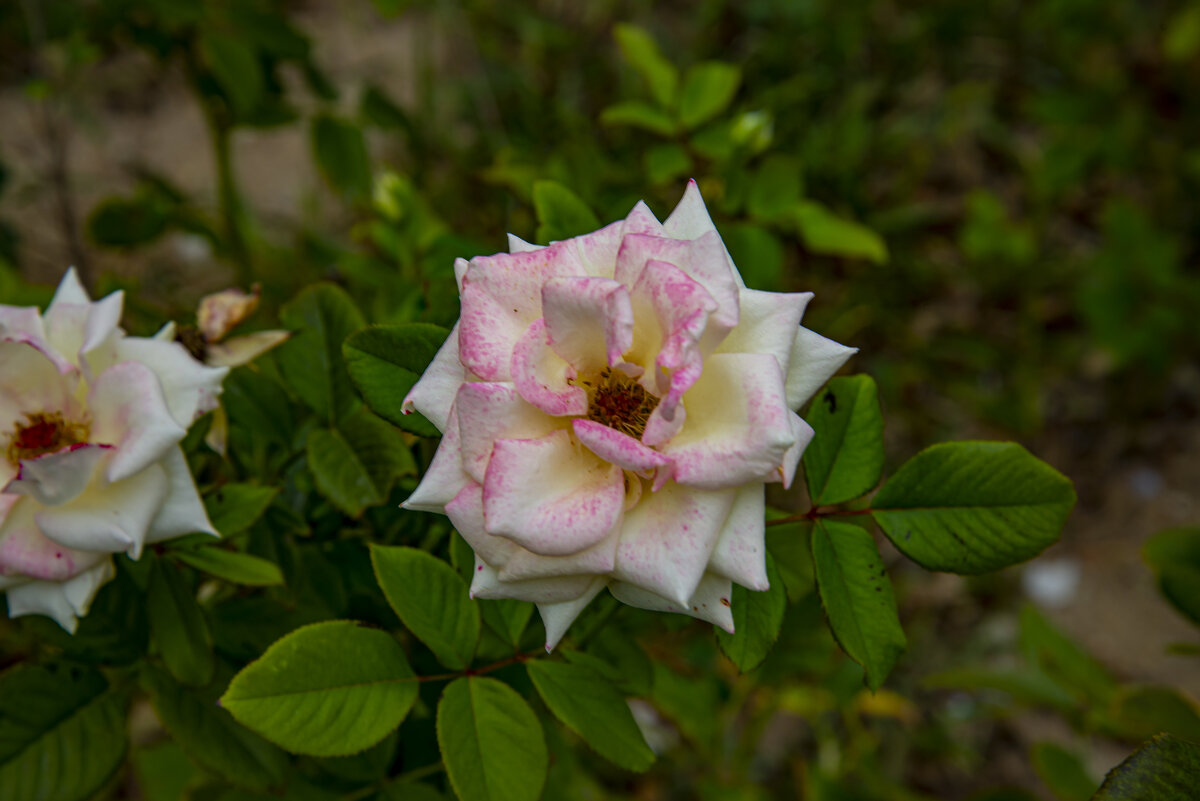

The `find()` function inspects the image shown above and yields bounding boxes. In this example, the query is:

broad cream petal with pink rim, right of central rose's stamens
[661,354,796,489]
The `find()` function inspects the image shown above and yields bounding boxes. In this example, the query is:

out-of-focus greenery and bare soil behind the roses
[0,0,1200,799]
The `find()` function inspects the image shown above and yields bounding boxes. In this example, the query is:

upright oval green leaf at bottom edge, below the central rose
[438,676,550,801]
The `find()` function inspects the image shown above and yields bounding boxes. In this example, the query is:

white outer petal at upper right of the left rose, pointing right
[117,337,229,428]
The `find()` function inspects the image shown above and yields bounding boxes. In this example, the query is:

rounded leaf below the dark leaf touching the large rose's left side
[306,409,416,517]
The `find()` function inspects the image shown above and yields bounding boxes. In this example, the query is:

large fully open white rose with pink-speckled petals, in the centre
[404,182,854,649]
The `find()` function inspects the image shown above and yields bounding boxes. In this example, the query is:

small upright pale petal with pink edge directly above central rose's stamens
[541,277,634,372]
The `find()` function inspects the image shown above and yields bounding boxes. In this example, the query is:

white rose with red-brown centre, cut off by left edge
[0,270,228,632]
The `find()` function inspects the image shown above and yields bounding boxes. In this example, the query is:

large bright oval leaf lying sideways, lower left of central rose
[221,620,418,757]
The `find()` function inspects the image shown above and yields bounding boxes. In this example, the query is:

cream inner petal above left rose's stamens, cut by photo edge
[0,341,83,436]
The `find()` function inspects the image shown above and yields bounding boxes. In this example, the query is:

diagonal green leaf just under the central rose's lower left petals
[371,546,479,670]
